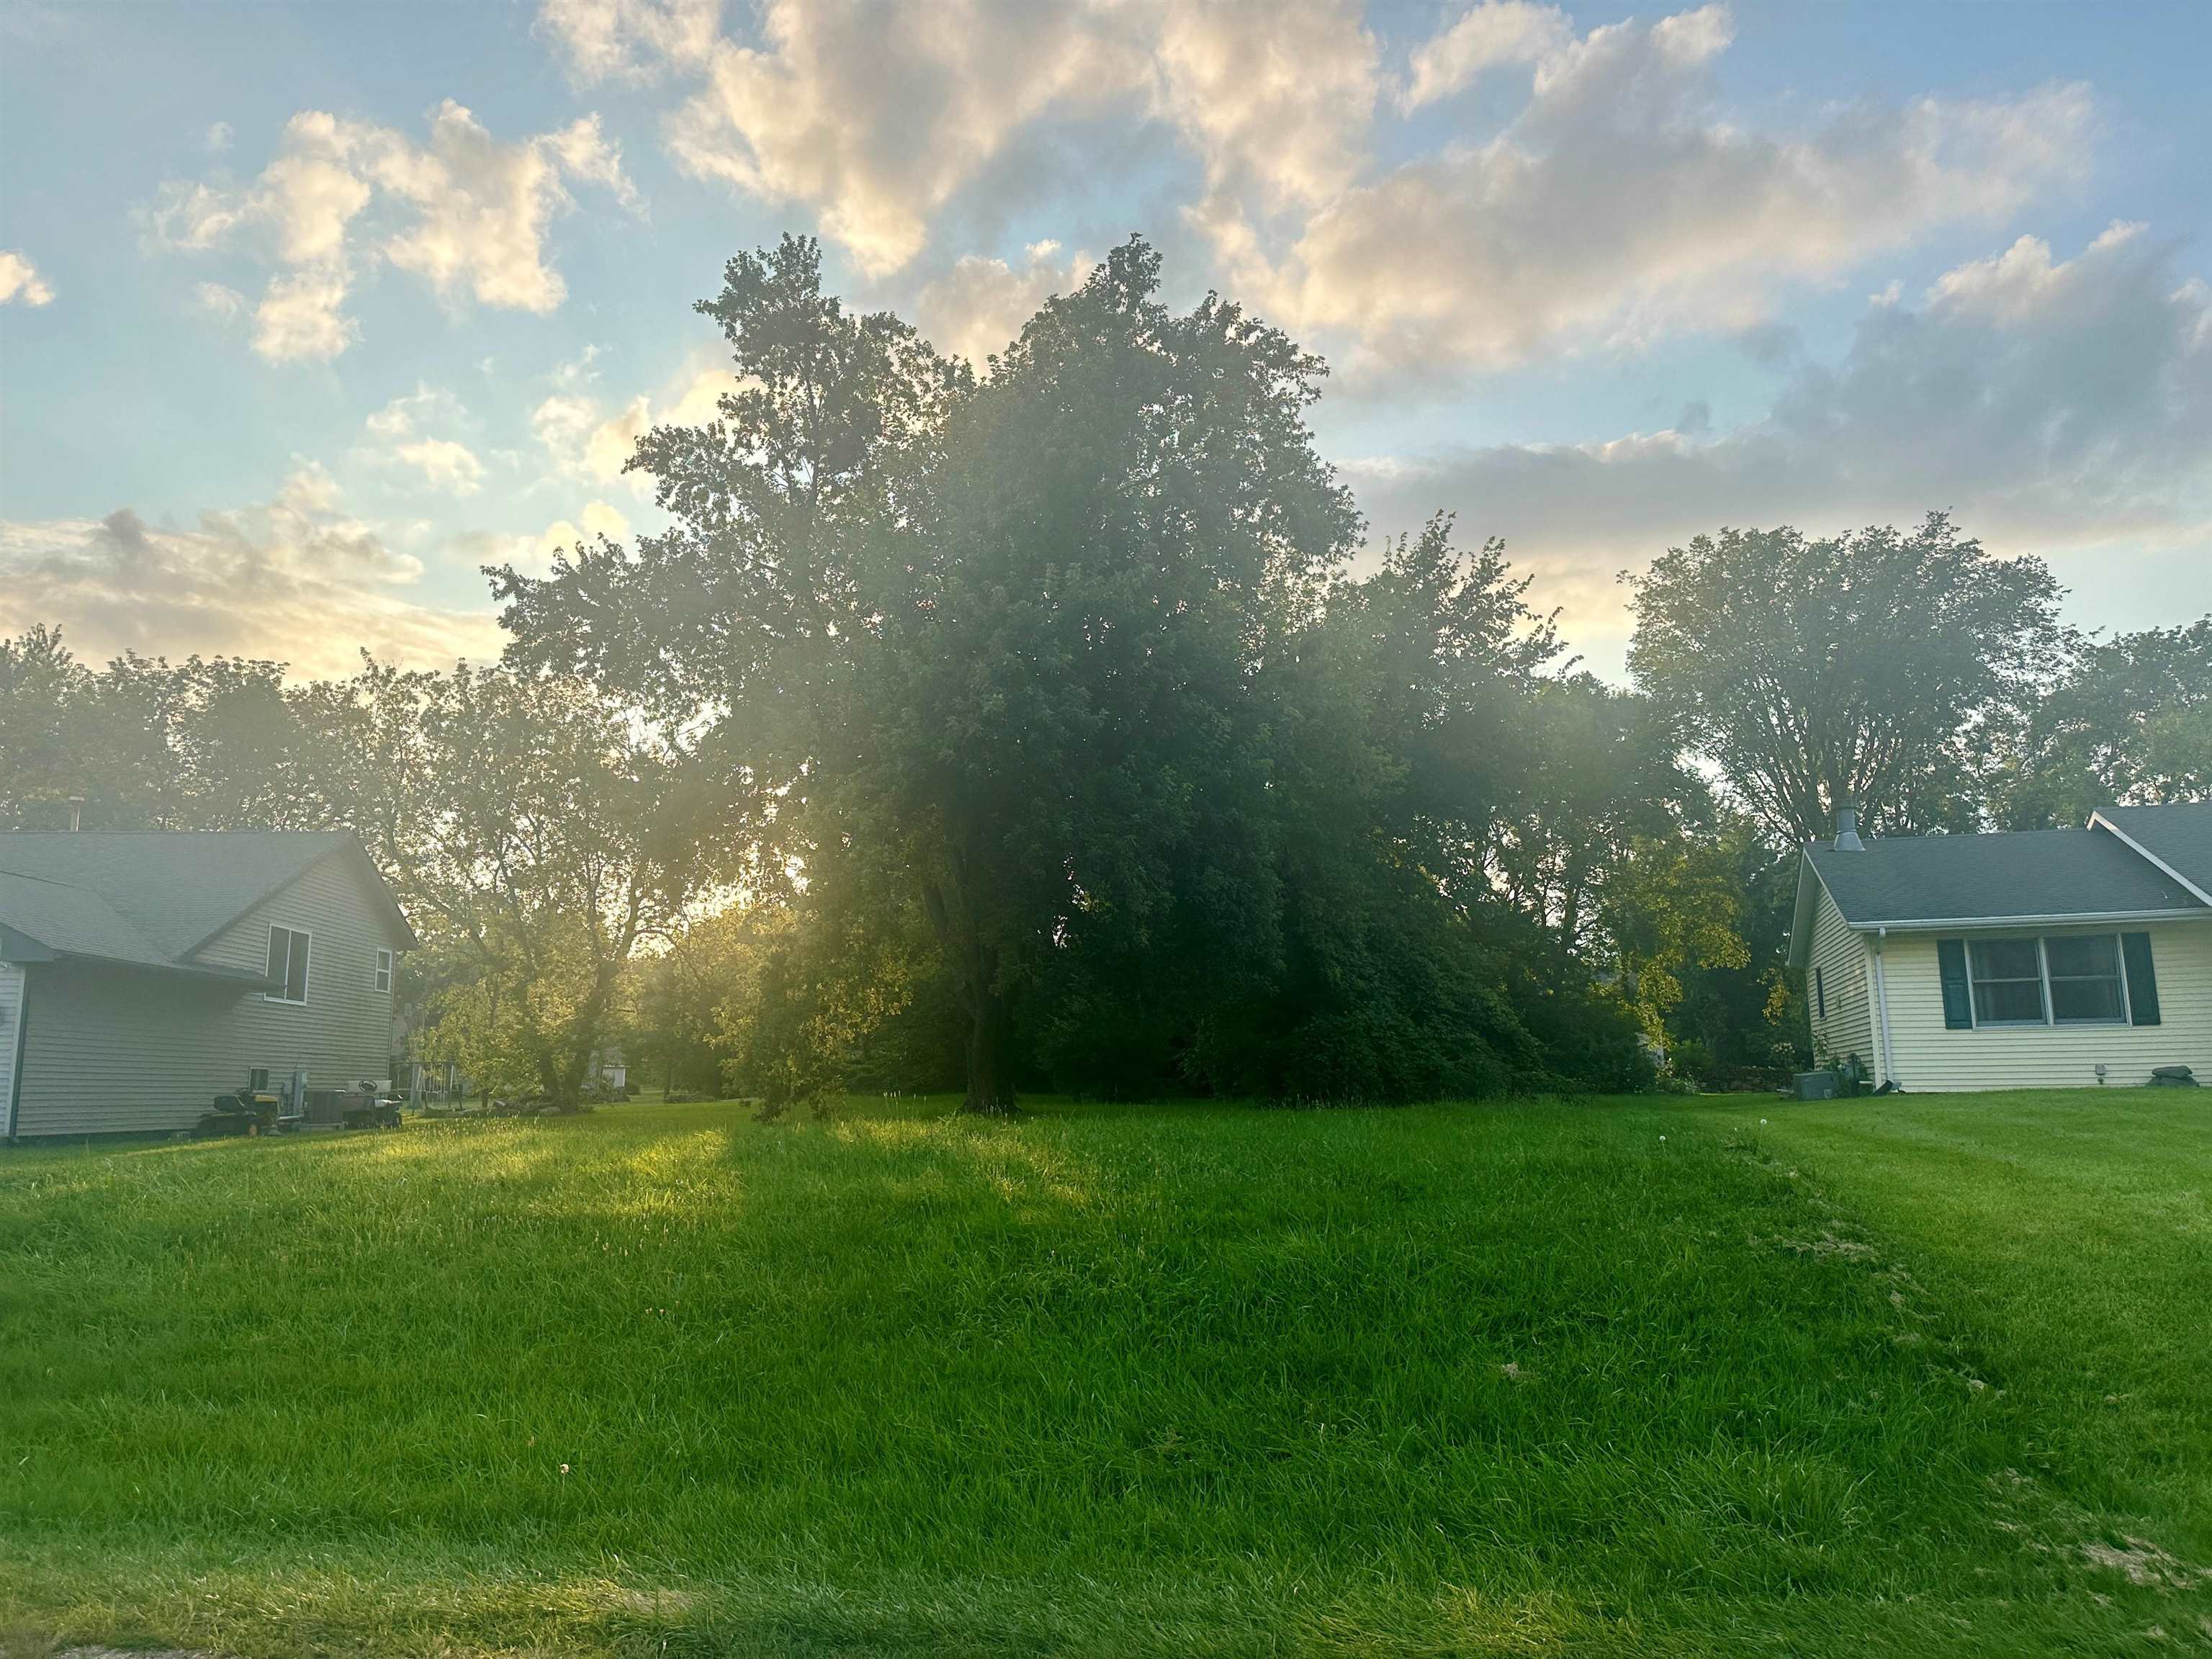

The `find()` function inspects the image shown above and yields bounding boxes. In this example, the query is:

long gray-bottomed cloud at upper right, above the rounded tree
[1246,6,2090,367]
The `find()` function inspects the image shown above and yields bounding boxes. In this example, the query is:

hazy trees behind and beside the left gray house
[0,628,737,1100]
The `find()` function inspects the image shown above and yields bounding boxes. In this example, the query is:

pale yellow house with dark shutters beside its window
[1789,803,2212,1090]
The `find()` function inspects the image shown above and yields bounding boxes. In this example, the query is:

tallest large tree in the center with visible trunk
[498,239,1358,1110]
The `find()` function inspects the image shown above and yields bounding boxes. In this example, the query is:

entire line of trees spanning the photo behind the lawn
[0,239,2212,1110]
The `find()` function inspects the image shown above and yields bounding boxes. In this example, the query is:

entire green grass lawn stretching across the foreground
[0,1095,2212,1657]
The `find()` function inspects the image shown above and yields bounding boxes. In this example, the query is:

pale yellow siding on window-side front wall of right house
[1866,922,2212,1090]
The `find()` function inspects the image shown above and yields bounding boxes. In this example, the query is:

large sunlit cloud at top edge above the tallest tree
[540,0,1380,276]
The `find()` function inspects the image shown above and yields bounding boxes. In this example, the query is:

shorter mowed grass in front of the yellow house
[1710,1088,2212,1562]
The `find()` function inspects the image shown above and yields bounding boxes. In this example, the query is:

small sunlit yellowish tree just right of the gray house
[297,662,734,1106]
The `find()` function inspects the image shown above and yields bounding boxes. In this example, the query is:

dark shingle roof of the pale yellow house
[1805,827,2206,927]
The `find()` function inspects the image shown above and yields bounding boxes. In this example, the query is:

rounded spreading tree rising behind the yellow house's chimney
[1628,513,2062,845]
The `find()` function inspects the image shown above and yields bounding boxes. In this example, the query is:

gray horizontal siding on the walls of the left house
[16,856,392,1135]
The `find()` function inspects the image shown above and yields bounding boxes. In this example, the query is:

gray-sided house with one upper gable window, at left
[0,830,413,1139]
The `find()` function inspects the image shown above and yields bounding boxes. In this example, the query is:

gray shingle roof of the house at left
[0,830,405,971]
